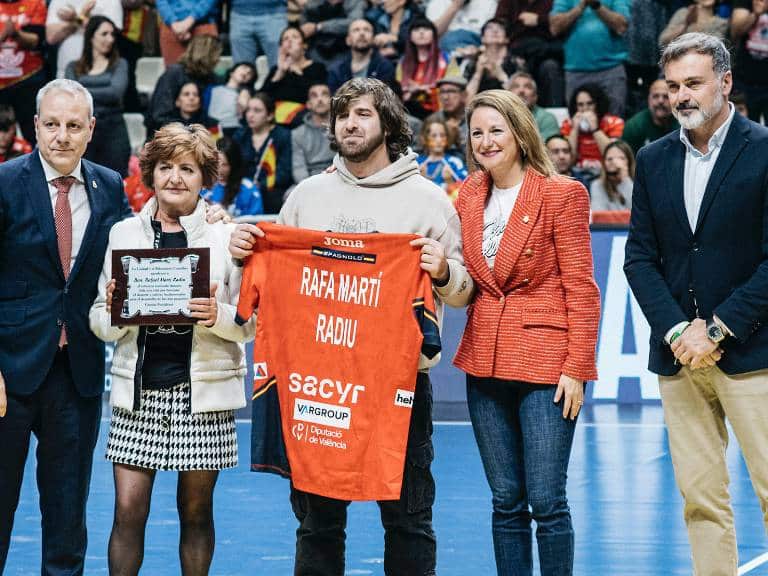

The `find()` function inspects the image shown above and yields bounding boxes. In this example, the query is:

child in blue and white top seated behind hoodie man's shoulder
[417,116,467,201]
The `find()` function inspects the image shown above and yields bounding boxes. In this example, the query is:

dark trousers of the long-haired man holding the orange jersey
[291,373,437,576]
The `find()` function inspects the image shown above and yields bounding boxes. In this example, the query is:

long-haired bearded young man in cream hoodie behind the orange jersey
[230,78,472,576]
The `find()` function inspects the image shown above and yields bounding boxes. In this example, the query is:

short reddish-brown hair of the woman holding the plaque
[139,122,219,189]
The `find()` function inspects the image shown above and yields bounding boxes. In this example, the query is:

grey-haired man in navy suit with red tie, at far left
[0,80,130,575]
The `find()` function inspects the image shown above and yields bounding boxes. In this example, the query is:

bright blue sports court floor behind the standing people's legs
[5,404,768,576]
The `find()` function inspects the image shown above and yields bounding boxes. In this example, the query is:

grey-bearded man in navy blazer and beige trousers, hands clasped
[624,33,768,576]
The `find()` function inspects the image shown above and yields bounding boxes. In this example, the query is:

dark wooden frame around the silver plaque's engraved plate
[111,248,211,326]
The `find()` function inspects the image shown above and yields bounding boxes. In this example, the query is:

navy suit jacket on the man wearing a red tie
[0,149,131,396]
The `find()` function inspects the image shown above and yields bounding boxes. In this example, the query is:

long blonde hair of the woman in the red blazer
[467,90,556,176]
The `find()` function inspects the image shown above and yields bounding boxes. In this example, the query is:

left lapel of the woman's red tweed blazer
[460,171,501,296]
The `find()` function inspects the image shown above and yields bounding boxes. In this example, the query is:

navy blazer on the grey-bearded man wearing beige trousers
[624,113,768,376]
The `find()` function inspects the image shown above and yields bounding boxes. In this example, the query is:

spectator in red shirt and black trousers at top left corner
[0,0,46,145]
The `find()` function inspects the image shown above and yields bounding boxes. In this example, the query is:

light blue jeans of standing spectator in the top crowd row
[229,12,288,67]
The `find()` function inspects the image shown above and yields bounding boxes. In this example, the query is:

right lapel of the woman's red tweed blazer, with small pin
[496,168,544,287]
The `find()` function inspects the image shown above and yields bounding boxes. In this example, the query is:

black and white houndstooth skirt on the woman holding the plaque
[107,383,237,471]
